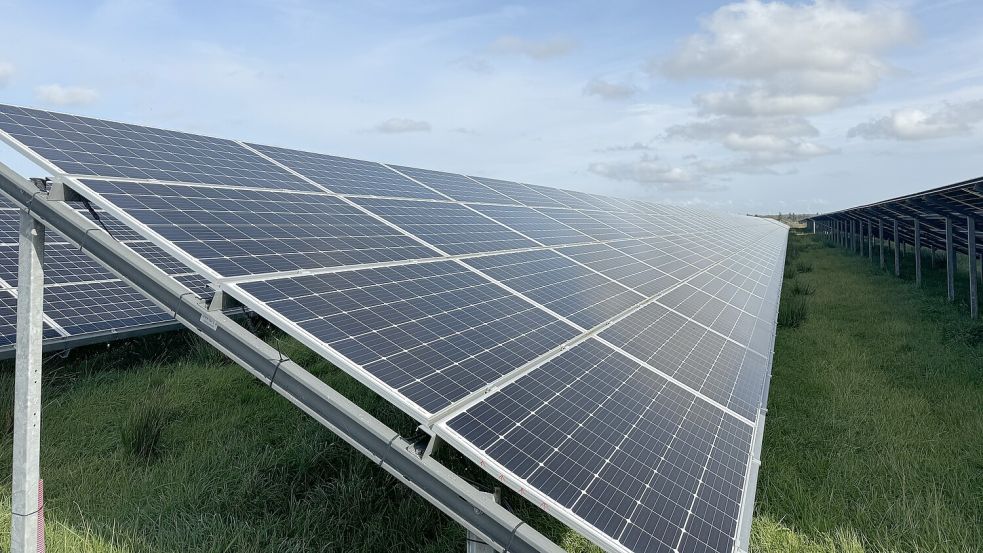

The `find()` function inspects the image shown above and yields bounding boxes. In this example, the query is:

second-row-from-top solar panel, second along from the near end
[353,198,539,255]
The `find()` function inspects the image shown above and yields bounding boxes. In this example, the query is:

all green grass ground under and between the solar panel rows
[0,231,983,553]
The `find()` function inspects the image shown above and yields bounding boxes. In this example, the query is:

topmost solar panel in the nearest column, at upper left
[0,105,316,190]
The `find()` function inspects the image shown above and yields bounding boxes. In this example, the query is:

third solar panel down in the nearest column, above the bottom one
[239,261,578,416]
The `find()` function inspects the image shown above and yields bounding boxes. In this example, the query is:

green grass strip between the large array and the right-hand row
[752,232,983,552]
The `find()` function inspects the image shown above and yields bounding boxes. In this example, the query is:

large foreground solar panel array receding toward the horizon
[0,106,786,551]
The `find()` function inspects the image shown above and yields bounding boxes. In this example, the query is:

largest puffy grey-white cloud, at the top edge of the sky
[650,0,914,116]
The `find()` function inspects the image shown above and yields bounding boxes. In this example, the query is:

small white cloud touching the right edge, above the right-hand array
[847,99,983,140]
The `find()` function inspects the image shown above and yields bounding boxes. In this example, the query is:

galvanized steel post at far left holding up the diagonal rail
[10,211,44,553]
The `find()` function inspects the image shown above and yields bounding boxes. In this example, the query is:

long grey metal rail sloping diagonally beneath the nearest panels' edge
[0,160,562,553]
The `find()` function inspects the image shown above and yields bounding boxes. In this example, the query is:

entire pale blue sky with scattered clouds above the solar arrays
[0,0,983,213]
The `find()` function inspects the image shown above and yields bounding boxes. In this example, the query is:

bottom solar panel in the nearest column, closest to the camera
[446,339,752,551]
